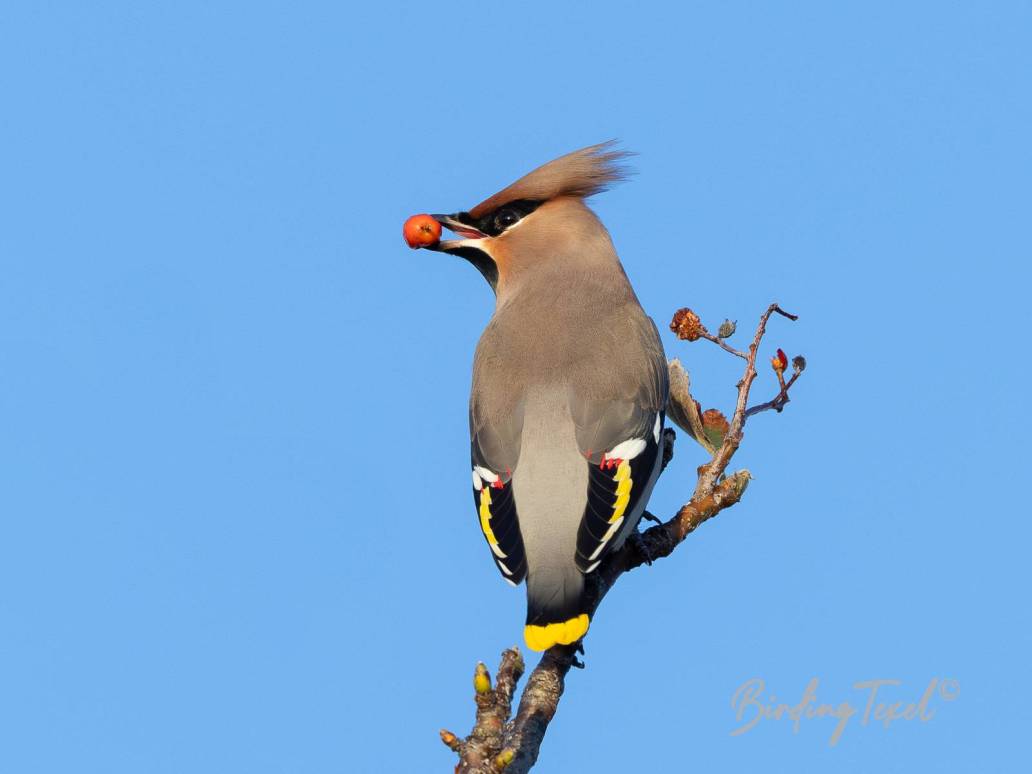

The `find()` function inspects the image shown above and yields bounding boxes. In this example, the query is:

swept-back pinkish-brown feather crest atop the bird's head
[470,140,632,218]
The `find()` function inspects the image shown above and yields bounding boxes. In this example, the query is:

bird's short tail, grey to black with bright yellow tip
[523,562,590,650]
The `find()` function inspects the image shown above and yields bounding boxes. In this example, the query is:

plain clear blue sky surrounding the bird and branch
[0,2,1032,774]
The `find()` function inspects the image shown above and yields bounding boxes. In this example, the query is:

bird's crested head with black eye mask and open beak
[409,142,628,292]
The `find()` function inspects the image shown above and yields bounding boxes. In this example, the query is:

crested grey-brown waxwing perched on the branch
[419,140,669,651]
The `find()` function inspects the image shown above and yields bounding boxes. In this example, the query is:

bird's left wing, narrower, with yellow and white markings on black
[470,399,526,586]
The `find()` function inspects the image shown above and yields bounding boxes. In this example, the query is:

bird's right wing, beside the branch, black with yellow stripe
[570,314,669,573]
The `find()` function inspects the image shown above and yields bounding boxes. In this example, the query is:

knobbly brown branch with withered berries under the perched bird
[441,303,805,774]
